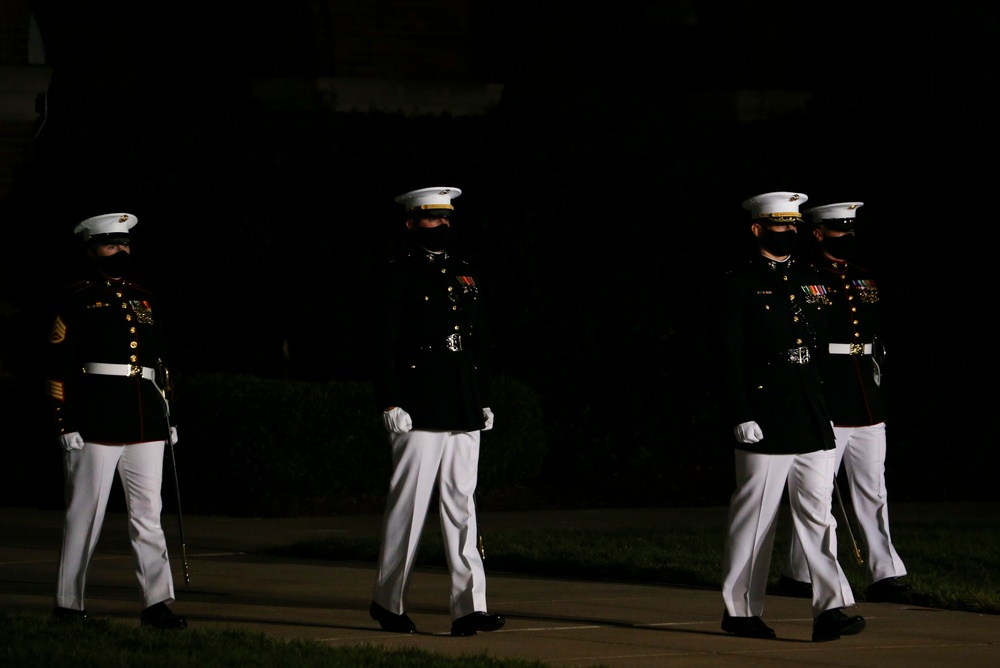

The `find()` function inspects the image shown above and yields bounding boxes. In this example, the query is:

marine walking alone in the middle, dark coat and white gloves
[369,187,505,636]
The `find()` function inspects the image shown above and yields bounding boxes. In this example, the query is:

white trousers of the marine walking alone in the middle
[373,430,487,619]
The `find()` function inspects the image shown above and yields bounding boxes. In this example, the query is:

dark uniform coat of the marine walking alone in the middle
[375,246,490,431]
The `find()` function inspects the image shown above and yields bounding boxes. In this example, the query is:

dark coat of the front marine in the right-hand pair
[713,255,834,454]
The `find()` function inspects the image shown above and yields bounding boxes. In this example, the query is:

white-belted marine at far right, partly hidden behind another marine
[782,202,913,603]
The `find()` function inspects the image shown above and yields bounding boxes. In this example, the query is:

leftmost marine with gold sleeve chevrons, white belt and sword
[46,213,187,629]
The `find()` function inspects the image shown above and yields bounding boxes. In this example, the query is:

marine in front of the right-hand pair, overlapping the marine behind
[717,191,865,641]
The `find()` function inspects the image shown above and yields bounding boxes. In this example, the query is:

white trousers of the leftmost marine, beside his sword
[56,441,174,610]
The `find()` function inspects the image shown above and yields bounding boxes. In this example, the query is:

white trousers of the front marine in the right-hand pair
[722,450,854,618]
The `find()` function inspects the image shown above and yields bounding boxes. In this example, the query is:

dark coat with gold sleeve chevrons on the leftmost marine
[46,279,173,445]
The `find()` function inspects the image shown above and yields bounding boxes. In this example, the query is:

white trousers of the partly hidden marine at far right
[783,422,906,584]
